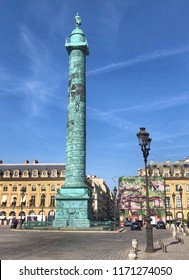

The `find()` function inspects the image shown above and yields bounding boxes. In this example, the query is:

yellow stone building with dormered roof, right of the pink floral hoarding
[138,157,189,223]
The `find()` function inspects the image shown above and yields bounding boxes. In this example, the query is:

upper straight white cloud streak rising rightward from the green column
[87,46,189,76]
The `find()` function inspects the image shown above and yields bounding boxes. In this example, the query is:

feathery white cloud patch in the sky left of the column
[0,26,66,118]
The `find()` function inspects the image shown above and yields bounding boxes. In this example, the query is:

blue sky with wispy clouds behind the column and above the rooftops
[0,0,189,188]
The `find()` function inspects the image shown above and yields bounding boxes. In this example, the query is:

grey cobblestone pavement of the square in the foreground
[0,227,189,260]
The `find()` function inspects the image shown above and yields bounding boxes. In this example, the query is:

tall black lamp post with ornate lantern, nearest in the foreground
[137,127,154,252]
